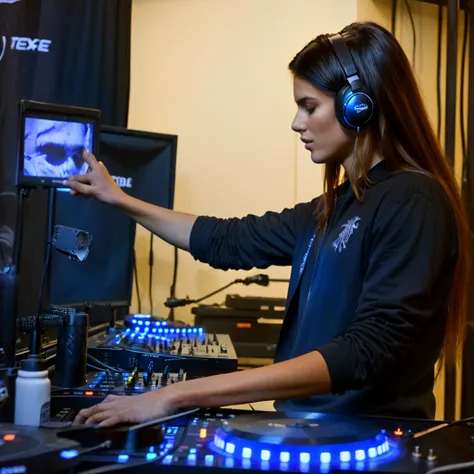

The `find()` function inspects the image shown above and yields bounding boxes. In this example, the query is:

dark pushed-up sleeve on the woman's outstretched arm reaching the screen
[190,199,317,270]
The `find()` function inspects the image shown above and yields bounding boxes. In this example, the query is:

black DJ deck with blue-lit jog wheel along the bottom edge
[0,409,474,474]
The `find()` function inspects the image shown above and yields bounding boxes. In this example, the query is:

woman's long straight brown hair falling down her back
[289,22,471,362]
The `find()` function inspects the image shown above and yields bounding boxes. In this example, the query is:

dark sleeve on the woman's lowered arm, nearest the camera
[317,193,457,394]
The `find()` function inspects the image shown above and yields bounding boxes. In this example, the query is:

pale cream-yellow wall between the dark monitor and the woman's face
[128,0,356,320]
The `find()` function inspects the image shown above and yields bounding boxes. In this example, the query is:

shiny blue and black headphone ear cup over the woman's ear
[335,85,374,130]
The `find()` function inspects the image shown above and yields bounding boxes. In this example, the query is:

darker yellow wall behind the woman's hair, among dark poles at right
[357,0,468,419]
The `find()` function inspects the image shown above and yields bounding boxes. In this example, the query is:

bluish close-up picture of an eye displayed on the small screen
[23,117,95,178]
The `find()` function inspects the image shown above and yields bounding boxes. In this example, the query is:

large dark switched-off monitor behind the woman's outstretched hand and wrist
[49,126,177,312]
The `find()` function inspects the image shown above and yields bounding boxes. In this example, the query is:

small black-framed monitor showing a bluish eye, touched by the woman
[17,100,100,187]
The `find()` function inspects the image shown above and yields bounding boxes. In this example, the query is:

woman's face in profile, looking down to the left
[291,76,355,164]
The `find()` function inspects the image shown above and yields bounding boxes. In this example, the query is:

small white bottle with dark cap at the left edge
[15,356,51,426]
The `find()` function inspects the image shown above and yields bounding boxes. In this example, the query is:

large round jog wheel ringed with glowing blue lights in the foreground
[210,413,399,471]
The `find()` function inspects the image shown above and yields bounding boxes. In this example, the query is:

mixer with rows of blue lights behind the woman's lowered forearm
[88,315,238,377]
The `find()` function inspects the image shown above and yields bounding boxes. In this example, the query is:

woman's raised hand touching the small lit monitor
[64,152,125,205]
